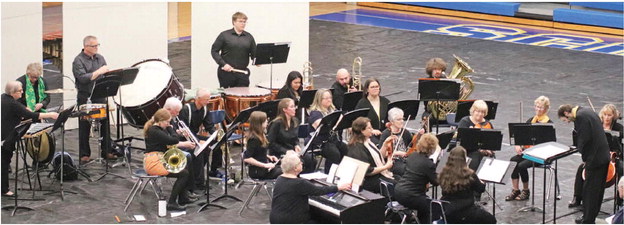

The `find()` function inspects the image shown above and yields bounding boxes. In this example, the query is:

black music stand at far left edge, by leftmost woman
[2,122,34,216]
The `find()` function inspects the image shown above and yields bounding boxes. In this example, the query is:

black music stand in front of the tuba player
[418,78,461,133]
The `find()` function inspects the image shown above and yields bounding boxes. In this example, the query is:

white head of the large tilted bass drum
[115,60,173,107]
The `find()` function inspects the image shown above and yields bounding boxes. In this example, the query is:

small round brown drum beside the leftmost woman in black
[25,132,56,164]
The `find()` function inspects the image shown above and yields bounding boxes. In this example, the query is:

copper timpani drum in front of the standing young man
[224,87,271,120]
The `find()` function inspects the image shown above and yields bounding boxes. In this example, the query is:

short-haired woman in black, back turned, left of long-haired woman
[394,133,438,223]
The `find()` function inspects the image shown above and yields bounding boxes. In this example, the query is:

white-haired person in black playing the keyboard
[269,151,351,224]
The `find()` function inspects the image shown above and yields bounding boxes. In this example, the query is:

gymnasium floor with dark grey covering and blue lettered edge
[1,3,624,223]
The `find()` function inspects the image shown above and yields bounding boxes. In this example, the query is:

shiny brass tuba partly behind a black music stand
[428,54,474,120]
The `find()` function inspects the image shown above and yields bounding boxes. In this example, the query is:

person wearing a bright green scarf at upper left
[17,62,50,112]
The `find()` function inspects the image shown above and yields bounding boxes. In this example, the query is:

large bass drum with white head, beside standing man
[115,59,184,129]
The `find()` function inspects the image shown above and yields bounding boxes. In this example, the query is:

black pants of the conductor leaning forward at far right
[582,164,609,223]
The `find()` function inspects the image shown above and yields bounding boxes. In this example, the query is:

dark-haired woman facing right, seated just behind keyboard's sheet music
[347,117,396,193]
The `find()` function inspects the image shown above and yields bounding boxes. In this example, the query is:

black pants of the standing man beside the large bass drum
[78,98,111,158]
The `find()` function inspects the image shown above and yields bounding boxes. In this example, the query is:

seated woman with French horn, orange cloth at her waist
[143,109,197,211]
